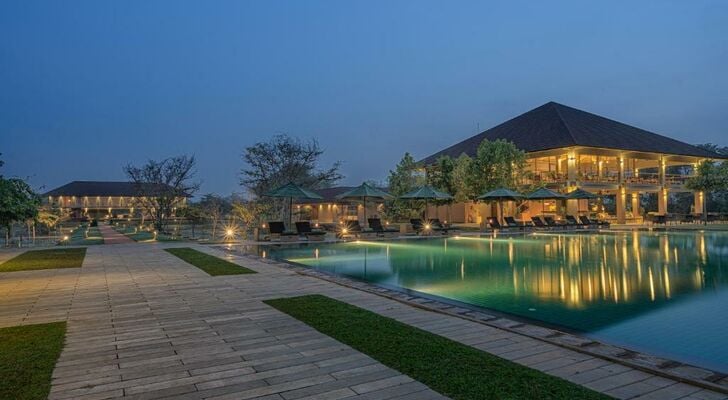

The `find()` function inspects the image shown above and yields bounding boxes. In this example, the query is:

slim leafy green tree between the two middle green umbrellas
[385,153,425,220]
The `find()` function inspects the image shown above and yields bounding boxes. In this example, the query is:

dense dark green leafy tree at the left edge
[0,177,40,245]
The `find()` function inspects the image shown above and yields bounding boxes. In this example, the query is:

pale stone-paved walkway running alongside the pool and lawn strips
[0,244,728,400]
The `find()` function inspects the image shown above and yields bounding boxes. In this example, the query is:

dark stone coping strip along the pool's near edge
[228,246,728,394]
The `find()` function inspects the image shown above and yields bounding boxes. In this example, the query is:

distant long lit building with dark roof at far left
[43,181,187,219]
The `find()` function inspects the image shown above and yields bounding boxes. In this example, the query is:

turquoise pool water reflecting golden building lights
[258,232,728,372]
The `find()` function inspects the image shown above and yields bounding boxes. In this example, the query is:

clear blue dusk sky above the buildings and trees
[0,0,728,198]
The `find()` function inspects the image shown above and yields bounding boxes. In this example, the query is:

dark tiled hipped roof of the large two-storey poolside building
[420,102,725,164]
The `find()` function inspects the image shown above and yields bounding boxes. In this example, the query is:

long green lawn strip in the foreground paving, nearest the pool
[265,295,609,399]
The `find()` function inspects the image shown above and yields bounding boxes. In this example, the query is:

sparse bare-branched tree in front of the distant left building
[124,155,200,232]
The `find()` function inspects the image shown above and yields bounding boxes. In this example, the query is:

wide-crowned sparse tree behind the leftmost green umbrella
[240,135,343,198]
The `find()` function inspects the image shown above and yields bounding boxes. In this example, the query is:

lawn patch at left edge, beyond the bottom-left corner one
[0,247,86,272]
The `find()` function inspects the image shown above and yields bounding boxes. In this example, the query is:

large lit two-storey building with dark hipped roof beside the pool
[420,102,725,223]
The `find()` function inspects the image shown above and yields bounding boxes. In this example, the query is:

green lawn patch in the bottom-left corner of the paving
[0,322,66,400]
